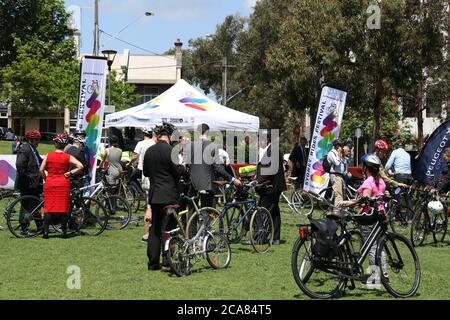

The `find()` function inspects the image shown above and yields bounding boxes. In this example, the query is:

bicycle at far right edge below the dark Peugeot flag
[410,189,448,247]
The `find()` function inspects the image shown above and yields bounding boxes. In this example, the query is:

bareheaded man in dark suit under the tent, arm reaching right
[188,123,241,207]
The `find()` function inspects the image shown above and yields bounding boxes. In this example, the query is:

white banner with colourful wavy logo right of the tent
[303,86,347,194]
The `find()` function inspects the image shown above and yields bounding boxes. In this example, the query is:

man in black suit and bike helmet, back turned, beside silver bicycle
[143,123,185,271]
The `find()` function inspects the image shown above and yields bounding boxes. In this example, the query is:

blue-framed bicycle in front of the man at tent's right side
[187,183,274,253]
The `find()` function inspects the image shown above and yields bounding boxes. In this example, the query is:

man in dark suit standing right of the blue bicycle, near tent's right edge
[256,131,286,245]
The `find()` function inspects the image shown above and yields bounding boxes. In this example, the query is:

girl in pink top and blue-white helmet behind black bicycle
[338,153,386,288]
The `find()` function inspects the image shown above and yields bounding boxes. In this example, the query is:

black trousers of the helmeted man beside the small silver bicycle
[147,204,177,269]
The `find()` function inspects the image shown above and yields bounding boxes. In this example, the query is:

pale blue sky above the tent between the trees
[65,0,257,54]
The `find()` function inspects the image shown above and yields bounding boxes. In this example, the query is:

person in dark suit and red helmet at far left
[14,130,43,234]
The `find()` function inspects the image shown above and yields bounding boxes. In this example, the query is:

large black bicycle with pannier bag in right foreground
[291,198,421,299]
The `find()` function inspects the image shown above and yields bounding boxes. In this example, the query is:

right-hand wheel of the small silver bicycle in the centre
[205,232,231,269]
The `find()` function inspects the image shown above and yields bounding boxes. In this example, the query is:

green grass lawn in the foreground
[0,198,450,300]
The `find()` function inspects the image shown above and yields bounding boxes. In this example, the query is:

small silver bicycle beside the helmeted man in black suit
[165,191,231,277]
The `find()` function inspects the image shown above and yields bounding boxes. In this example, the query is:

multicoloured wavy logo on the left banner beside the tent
[86,86,102,171]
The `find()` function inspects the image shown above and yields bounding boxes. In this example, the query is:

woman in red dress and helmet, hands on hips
[39,134,83,239]
